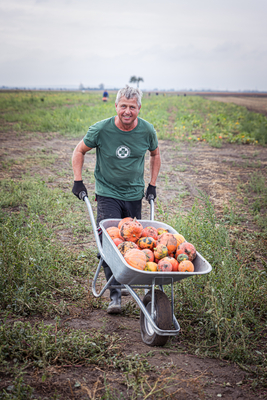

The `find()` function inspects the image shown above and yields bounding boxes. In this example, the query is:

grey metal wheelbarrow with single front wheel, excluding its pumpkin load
[80,192,212,346]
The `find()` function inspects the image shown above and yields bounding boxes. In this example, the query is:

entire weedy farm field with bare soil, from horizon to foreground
[0,92,267,400]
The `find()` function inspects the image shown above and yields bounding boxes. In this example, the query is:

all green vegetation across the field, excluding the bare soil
[0,92,267,399]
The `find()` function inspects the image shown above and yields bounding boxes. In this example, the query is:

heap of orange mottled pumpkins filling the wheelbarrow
[106,217,196,272]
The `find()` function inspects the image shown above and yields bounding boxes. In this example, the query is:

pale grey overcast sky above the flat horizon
[0,0,267,91]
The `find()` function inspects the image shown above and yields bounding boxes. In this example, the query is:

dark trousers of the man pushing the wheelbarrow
[96,195,142,297]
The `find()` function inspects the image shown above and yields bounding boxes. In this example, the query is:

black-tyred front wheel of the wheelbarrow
[140,290,172,346]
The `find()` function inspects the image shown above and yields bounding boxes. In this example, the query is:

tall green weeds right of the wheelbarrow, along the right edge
[159,195,267,386]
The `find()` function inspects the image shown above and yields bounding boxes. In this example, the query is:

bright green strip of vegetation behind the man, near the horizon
[0,92,267,147]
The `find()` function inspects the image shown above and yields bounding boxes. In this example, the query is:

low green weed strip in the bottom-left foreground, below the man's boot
[0,321,124,368]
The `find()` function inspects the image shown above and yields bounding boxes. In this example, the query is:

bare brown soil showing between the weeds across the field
[0,97,267,400]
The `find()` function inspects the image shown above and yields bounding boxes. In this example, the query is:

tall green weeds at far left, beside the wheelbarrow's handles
[0,179,94,315]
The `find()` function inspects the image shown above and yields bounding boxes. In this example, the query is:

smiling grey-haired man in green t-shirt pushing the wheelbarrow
[72,85,161,314]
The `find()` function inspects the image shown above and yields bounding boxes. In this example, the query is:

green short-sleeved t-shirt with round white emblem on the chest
[83,117,158,201]
